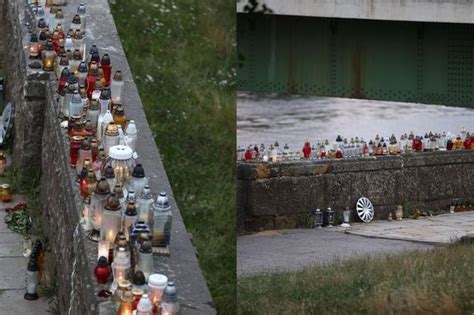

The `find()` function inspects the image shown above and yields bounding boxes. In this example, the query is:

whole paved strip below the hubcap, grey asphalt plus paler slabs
[237,211,474,276]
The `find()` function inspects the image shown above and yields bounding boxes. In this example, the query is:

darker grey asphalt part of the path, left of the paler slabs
[237,228,433,276]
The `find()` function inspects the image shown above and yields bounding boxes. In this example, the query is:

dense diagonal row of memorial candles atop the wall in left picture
[27,1,179,315]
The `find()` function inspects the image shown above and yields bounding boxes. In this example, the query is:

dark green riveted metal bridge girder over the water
[237,14,474,107]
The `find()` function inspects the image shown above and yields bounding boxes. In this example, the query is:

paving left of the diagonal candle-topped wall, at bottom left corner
[0,180,48,315]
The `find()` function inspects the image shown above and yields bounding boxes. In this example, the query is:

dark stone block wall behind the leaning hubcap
[237,150,474,233]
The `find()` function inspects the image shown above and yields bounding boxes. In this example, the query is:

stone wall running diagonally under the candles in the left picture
[0,0,215,315]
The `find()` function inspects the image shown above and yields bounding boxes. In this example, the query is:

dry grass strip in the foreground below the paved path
[238,240,474,314]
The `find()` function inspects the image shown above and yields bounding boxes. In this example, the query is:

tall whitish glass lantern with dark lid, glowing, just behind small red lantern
[100,193,122,244]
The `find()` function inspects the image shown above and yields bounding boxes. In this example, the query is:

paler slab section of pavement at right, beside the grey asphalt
[337,211,474,244]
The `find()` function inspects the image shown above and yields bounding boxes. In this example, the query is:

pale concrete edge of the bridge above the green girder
[237,0,474,23]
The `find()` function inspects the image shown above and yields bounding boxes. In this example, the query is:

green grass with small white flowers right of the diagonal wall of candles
[112,0,236,314]
